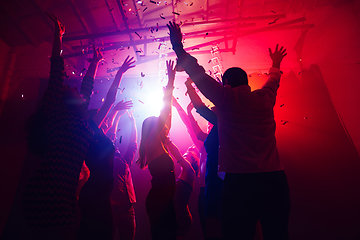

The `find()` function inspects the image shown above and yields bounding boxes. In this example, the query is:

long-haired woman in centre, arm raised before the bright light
[137,60,177,240]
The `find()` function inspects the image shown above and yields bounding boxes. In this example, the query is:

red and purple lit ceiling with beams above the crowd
[0,0,346,59]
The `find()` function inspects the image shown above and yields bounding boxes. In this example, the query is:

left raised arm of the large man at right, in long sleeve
[167,22,224,105]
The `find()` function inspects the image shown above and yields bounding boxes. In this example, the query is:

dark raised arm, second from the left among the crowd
[80,45,104,110]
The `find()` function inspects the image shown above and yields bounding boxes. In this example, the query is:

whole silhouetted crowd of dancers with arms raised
[22,14,290,240]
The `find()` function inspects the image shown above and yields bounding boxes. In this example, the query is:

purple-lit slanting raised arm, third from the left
[93,56,135,126]
